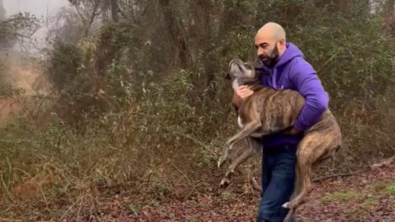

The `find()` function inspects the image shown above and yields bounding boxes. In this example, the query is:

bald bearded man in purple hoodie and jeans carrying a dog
[233,22,329,222]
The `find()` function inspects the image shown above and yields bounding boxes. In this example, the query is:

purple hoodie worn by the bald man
[261,43,329,147]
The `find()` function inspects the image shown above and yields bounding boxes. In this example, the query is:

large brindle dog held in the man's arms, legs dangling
[218,59,342,221]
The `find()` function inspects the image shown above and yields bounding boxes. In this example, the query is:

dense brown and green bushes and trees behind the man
[0,0,395,221]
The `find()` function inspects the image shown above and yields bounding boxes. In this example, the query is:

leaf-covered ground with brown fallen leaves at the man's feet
[79,159,395,222]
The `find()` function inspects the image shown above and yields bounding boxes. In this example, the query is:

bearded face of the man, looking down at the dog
[255,41,280,68]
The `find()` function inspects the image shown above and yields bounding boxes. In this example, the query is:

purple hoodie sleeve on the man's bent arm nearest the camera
[290,61,329,131]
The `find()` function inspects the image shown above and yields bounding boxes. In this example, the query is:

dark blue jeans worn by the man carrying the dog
[257,144,297,222]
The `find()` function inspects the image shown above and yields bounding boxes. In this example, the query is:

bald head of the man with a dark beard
[255,22,286,68]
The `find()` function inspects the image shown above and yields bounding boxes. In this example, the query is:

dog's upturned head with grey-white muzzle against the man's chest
[226,59,262,90]
